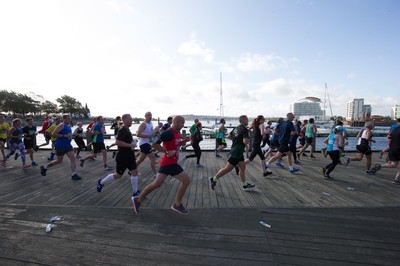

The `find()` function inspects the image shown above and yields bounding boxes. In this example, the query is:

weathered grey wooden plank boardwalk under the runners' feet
[0,151,400,265]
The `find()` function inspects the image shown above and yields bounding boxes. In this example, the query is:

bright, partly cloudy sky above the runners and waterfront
[0,0,400,118]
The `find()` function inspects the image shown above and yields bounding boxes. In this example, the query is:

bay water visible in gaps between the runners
[32,123,387,151]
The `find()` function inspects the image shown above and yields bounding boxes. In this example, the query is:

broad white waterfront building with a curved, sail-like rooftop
[290,97,324,120]
